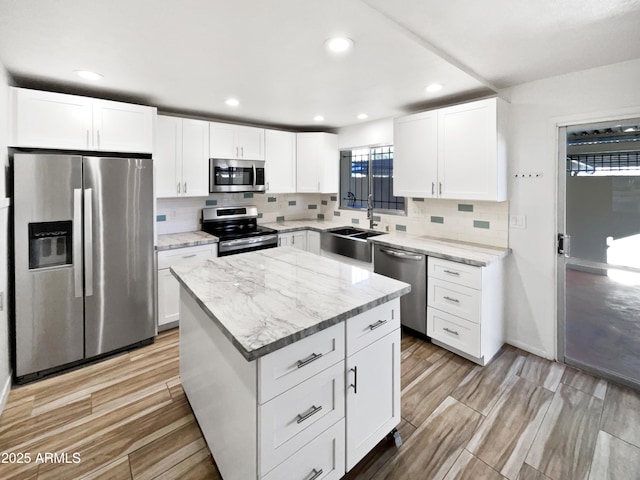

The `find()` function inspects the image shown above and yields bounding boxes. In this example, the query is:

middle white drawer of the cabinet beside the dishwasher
[427,278,480,323]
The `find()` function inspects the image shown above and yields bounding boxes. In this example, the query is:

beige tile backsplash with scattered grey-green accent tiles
[156,193,509,247]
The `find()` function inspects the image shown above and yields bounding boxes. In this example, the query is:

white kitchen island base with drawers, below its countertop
[180,289,400,480]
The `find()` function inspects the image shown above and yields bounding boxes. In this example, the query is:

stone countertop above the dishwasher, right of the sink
[368,233,511,267]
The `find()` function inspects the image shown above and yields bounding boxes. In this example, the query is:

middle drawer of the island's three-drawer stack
[258,361,345,472]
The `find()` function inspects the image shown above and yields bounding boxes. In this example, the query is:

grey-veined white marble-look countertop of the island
[171,247,411,361]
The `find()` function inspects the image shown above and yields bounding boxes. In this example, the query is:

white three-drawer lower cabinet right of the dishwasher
[427,257,504,365]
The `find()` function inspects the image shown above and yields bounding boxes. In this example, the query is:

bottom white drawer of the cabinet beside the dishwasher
[427,307,481,357]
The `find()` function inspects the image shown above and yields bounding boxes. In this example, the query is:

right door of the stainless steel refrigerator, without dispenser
[83,157,156,358]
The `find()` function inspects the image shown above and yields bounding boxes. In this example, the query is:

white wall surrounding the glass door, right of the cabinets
[503,60,640,358]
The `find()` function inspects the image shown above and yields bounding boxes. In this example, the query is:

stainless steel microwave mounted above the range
[209,158,265,193]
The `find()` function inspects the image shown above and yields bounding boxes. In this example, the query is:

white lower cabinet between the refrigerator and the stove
[158,243,218,330]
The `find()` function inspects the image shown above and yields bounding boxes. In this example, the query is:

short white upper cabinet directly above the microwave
[209,122,265,160]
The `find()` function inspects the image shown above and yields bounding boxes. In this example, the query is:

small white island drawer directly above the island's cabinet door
[347,298,400,356]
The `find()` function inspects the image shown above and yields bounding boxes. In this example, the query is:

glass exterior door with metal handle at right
[558,119,640,388]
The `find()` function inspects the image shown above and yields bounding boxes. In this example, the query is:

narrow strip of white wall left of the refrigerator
[0,64,11,413]
